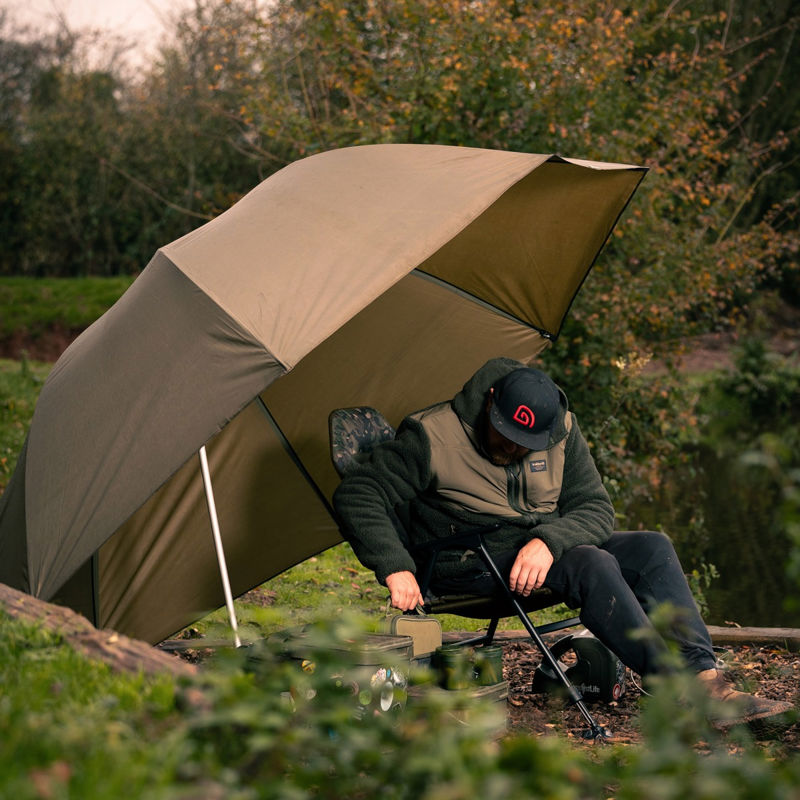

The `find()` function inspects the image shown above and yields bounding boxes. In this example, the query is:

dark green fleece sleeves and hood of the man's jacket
[333,358,614,583]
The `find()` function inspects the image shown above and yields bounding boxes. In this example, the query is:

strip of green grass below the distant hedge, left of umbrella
[0,275,134,338]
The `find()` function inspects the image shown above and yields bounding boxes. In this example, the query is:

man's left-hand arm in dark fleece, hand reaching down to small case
[333,420,430,610]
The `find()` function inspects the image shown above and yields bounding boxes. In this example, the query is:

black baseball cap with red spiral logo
[489,367,560,450]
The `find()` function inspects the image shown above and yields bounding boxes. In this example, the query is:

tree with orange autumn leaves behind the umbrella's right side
[203,0,798,504]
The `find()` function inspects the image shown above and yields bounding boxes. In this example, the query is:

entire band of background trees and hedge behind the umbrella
[0,0,800,504]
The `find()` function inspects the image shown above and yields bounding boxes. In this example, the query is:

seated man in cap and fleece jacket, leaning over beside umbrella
[334,358,790,717]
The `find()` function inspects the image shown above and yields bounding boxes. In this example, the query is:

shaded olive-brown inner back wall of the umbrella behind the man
[89,274,547,642]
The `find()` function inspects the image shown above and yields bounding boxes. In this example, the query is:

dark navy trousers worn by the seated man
[437,531,716,675]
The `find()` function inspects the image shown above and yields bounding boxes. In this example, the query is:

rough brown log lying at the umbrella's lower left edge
[0,583,197,677]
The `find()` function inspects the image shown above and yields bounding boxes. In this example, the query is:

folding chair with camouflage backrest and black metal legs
[328,406,609,739]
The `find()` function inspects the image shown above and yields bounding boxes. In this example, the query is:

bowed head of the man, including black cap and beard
[484,367,560,466]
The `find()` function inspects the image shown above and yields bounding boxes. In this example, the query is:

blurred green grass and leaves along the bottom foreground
[0,616,800,800]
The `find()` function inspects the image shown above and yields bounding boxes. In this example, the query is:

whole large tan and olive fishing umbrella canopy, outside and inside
[0,145,644,642]
